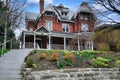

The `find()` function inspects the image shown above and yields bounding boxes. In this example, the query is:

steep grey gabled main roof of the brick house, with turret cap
[26,2,94,22]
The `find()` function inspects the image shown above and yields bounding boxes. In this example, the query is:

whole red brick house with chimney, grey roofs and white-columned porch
[22,0,95,50]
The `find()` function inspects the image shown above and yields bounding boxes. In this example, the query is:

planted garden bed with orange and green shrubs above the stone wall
[25,50,120,70]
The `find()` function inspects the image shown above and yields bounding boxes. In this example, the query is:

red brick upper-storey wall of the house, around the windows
[27,14,94,33]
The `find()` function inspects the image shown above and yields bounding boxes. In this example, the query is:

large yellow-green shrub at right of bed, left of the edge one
[92,57,109,67]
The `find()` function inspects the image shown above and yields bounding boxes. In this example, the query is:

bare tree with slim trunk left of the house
[0,0,26,48]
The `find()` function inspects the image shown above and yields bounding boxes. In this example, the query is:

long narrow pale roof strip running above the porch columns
[23,31,93,39]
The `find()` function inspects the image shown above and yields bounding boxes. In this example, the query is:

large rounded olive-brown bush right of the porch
[93,28,120,51]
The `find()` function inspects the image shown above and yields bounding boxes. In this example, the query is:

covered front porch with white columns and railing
[22,26,93,51]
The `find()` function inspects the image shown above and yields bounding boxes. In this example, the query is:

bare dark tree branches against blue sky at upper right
[93,0,120,23]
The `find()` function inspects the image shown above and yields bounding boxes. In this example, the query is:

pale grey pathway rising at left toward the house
[0,49,32,80]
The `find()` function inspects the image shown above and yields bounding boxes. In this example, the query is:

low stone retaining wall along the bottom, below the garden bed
[23,68,120,80]
